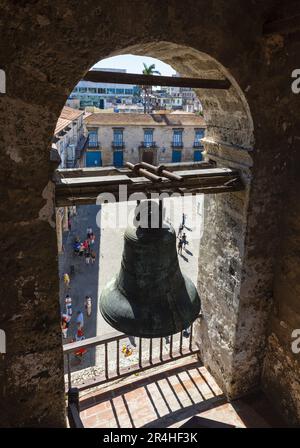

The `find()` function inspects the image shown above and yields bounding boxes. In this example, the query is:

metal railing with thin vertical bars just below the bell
[63,318,199,390]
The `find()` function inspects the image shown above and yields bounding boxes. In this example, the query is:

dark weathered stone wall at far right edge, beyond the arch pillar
[262,139,300,425]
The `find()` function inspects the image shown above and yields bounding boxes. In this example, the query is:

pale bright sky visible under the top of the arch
[94,54,176,76]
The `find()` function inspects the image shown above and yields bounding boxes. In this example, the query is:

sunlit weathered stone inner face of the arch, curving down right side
[90,41,254,397]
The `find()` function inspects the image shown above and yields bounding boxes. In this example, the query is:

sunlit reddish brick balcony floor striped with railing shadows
[80,357,285,428]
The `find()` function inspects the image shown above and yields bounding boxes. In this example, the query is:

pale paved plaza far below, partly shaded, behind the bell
[60,195,203,379]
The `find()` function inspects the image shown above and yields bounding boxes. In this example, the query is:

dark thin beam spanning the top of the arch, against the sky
[83,70,231,90]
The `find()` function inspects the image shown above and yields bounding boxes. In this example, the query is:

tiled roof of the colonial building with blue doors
[84,113,205,127]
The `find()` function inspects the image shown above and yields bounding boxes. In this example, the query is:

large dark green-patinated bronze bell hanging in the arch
[100,201,200,338]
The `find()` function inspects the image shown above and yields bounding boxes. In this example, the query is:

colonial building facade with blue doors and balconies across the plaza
[81,113,206,167]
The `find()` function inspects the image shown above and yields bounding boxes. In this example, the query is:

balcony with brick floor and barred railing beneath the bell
[64,327,281,428]
